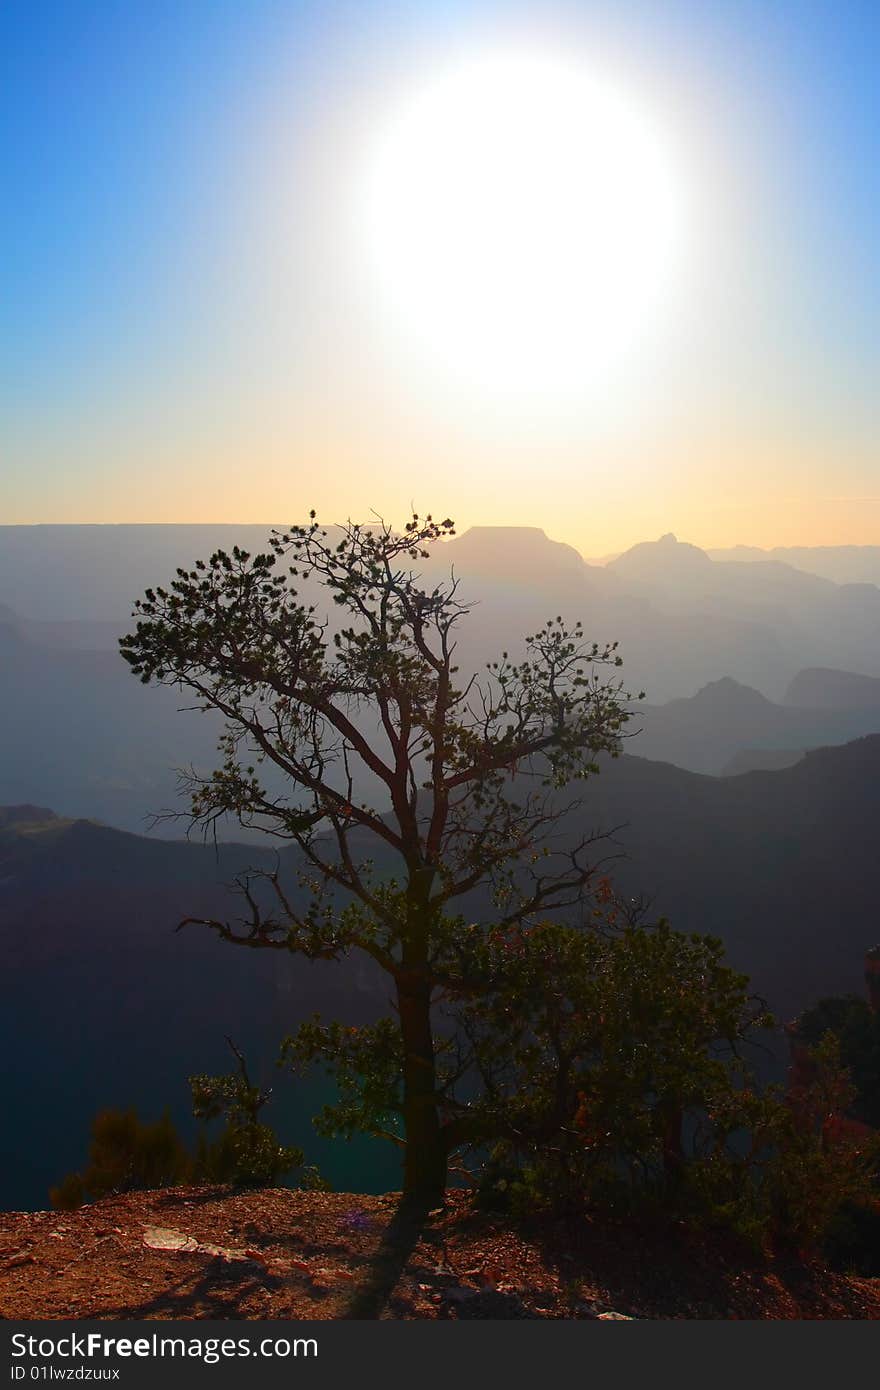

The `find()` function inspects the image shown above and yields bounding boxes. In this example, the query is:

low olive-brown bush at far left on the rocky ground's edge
[49,1109,192,1211]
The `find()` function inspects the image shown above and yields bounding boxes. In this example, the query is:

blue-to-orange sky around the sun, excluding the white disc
[0,0,880,555]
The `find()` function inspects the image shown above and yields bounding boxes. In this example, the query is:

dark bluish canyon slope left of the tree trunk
[0,806,399,1208]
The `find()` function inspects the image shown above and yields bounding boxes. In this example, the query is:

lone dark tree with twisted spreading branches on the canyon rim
[121,513,627,1200]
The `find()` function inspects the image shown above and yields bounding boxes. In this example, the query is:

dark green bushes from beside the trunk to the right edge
[460,923,880,1251]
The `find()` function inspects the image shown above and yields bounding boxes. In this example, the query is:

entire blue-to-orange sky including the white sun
[0,0,880,555]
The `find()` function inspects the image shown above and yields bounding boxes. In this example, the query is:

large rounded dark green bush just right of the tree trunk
[460,923,770,1207]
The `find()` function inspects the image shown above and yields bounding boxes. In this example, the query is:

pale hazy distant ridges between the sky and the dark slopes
[6,525,880,834]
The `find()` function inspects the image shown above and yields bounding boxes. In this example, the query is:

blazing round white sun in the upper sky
[357,53,687,403]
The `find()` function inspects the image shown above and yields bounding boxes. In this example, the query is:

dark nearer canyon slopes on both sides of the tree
[0,737,880,1205]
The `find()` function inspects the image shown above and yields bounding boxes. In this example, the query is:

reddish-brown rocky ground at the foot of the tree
[0,1188,880,1319]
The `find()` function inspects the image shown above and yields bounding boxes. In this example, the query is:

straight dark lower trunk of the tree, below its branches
[398,977,448,1205]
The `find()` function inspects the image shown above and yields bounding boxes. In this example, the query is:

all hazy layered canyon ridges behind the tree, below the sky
[0,527,880,1205]
